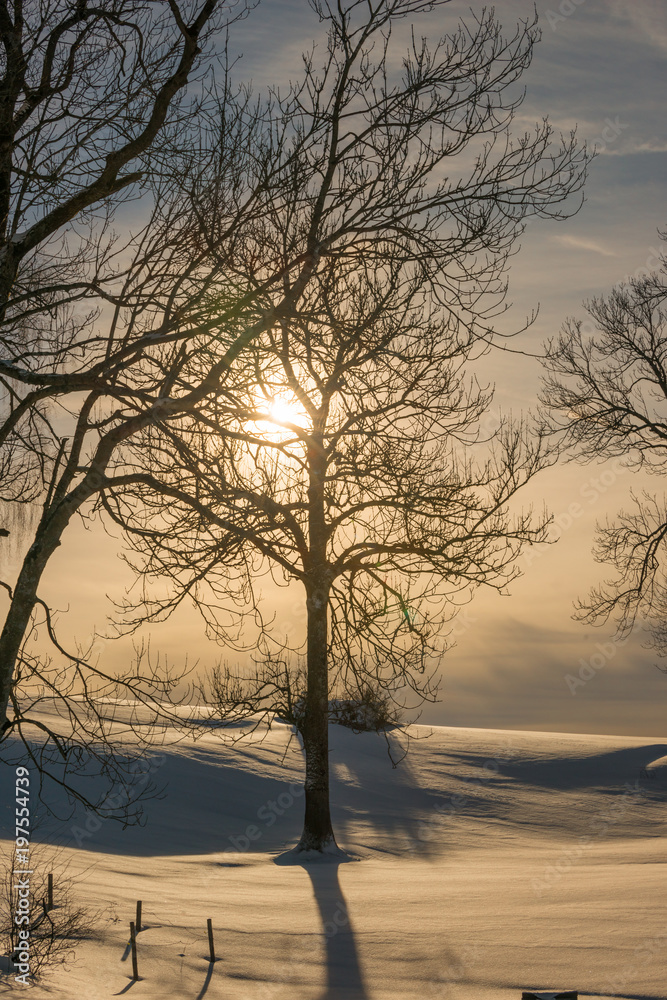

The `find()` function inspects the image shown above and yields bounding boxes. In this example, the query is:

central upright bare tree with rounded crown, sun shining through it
[108,261,550,851]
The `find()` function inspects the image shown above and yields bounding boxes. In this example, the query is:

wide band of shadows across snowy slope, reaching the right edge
[5,725,667,860]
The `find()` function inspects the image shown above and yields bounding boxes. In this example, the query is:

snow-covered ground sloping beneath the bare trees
[2,724,667,1000]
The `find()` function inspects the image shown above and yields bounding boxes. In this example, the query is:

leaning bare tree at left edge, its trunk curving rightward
[0,58,366,808]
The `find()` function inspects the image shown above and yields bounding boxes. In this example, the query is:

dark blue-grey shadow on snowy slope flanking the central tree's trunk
[5,725,444,866]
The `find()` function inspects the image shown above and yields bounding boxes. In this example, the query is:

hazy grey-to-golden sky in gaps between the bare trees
[3,0,667,736]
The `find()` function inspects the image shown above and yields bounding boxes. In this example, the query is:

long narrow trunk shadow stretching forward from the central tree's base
[301,860,368,1000]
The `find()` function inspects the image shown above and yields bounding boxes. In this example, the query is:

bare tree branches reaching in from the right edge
[542,239,667,655]
